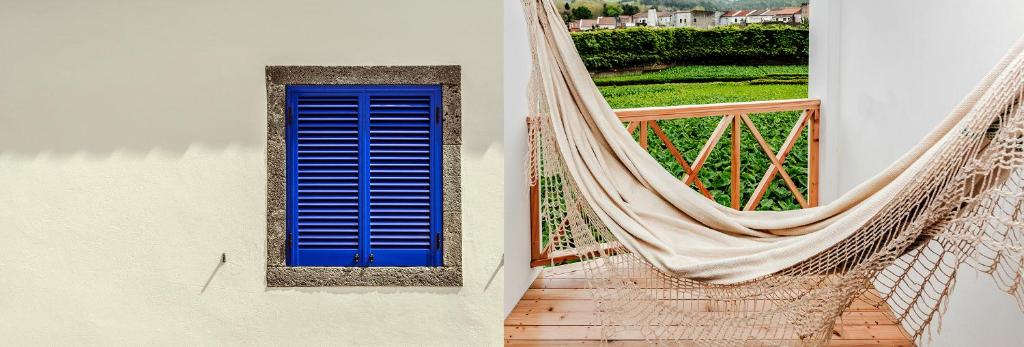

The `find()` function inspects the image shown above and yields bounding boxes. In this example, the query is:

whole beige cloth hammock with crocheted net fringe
[523,0,1024,346]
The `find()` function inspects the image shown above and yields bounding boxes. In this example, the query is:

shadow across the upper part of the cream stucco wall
[0,2,502,156]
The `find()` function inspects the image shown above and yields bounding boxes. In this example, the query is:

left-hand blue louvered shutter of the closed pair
[289,91,360,266]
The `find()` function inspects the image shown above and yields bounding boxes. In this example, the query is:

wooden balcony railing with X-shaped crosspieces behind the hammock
[530,99,821,266]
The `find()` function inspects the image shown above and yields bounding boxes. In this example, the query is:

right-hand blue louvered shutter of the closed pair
[369,88,440,266]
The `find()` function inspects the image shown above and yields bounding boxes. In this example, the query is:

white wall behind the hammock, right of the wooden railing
[811,0,1024,346]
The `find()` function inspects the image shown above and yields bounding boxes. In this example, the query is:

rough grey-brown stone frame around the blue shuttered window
[265,66,463,287]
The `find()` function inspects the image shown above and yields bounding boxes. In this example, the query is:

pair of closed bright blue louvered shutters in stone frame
[287,86,441,266]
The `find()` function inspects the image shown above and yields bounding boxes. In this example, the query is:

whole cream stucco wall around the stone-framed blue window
[0,0,504,346]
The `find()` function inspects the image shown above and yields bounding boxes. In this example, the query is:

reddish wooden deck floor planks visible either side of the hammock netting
[505,265,913,346]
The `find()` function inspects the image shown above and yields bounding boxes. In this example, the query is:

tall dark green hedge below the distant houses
[572,26,808,71]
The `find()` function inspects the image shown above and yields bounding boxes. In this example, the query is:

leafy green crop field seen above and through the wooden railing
[600,77,807,210]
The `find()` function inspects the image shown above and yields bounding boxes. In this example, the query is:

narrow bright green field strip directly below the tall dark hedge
[594,66,807,86]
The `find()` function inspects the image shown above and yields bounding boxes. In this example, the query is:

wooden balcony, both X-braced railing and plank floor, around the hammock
[505,99,913,346]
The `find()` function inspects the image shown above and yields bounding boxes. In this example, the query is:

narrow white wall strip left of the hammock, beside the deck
[503,0,540,315]
